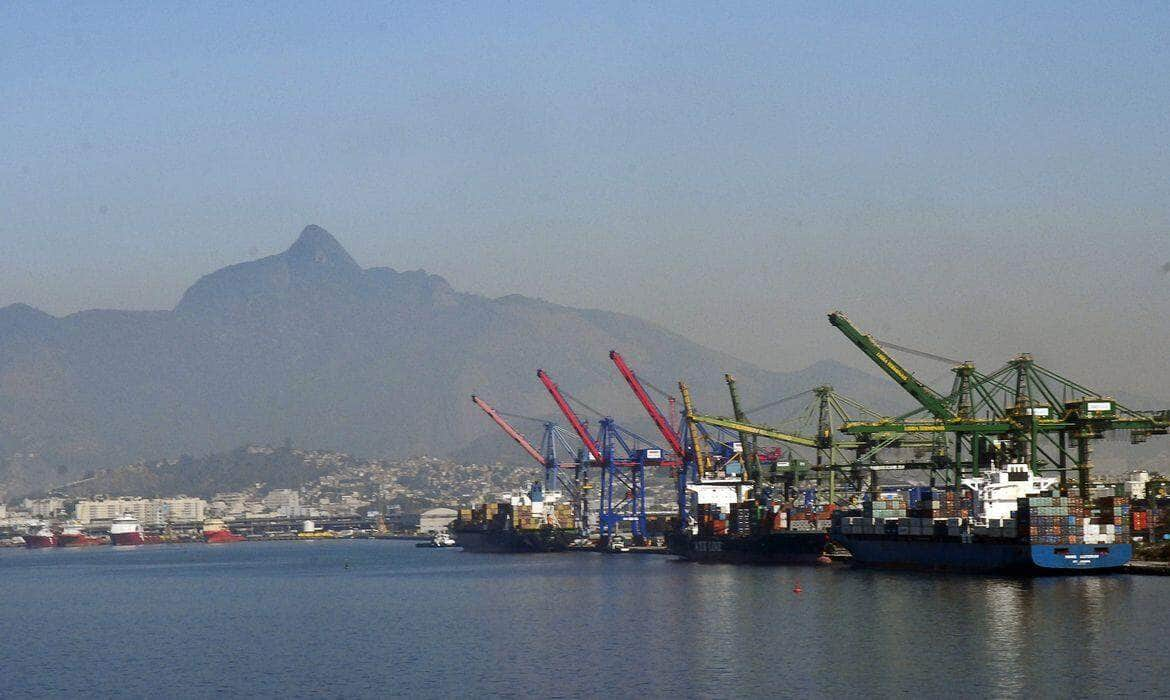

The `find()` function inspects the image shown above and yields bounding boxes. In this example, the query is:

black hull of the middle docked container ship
[667,530,828,564]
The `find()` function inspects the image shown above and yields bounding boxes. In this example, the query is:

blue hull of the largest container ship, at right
[834,535,1133,575]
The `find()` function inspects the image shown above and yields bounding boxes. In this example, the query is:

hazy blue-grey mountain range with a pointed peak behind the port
[0,226,896,497]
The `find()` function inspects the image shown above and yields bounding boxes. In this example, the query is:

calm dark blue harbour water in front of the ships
[0,541,1170,698]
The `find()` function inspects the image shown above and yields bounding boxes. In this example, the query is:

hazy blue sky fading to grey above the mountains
[0,2,1170,397]
